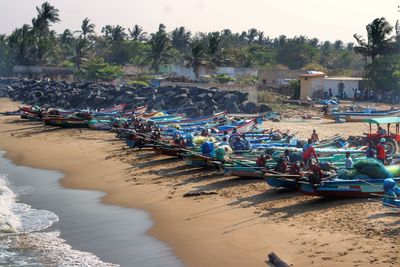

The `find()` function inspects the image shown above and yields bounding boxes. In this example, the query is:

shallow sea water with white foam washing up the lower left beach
[0,152,182,267]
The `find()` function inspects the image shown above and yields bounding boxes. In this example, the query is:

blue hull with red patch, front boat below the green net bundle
[299,178,400,198]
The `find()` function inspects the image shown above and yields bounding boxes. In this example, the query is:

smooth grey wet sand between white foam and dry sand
[0,152,182,267]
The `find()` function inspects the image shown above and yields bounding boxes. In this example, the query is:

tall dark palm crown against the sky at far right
[353,18,393,63]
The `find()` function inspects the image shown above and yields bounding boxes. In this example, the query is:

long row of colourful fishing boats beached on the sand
[15,105,400,208]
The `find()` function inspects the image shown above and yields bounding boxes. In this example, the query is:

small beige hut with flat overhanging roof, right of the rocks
[300,71,325,99]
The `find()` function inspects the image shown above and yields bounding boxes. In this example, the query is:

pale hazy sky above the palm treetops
[0,0,400,42]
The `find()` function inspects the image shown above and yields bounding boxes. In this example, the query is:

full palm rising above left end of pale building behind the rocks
[142,24,172,72]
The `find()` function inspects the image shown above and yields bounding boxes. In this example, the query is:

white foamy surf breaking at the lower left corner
[0,174,117,267]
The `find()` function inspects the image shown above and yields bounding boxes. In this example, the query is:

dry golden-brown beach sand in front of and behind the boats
[0,99,400,266]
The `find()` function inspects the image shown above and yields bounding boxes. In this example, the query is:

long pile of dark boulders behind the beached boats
[0,78,270,116]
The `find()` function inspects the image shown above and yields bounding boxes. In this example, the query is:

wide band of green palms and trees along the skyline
[0,2,400,92]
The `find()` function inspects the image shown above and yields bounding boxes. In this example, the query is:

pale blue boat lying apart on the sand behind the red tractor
[326,109,400,122]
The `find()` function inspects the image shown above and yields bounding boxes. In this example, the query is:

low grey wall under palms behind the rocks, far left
[13,65,75,81]
